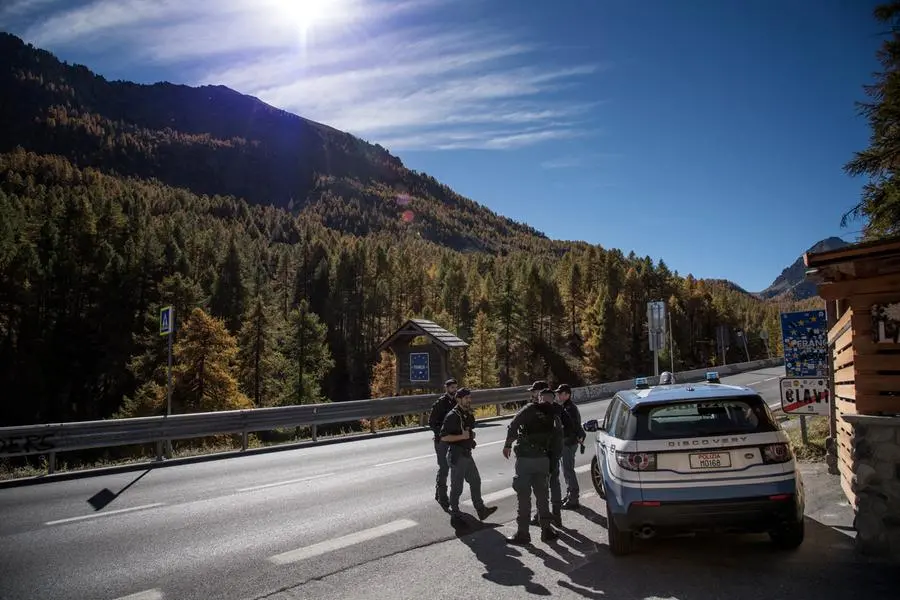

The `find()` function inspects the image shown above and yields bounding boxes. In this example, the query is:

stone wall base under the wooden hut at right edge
[842,415,900,562]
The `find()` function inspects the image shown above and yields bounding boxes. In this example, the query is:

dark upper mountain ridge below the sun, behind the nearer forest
[0,33,548,253]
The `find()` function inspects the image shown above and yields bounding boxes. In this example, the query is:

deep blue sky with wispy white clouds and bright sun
[0,0,880,291]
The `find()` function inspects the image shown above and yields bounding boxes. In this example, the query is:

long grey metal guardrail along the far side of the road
[0,358,784,473]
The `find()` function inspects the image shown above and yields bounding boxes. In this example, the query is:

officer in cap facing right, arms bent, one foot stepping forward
[440,388,497,521]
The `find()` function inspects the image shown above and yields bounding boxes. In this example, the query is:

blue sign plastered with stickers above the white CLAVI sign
[781,310,828,377]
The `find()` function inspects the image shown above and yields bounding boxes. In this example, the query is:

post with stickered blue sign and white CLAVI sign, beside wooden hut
[779,310,831,445]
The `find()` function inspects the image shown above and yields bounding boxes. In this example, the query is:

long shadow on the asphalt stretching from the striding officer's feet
[454,514,551,596]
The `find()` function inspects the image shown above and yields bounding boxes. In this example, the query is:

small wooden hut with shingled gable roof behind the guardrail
[377,319,469,394]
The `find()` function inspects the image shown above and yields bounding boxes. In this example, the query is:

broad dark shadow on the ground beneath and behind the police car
[556,519,900,600]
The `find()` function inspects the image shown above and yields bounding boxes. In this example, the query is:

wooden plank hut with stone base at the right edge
[804,238,900,559]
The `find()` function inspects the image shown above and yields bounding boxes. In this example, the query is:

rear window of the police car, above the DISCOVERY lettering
[635,396,778,440]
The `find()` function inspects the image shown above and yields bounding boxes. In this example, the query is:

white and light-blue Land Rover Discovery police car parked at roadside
[584,372,804,555]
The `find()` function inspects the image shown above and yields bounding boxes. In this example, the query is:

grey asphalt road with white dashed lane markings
[0,368,884,600]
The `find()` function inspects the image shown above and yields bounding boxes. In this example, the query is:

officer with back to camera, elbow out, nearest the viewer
[503,382,562,545]
